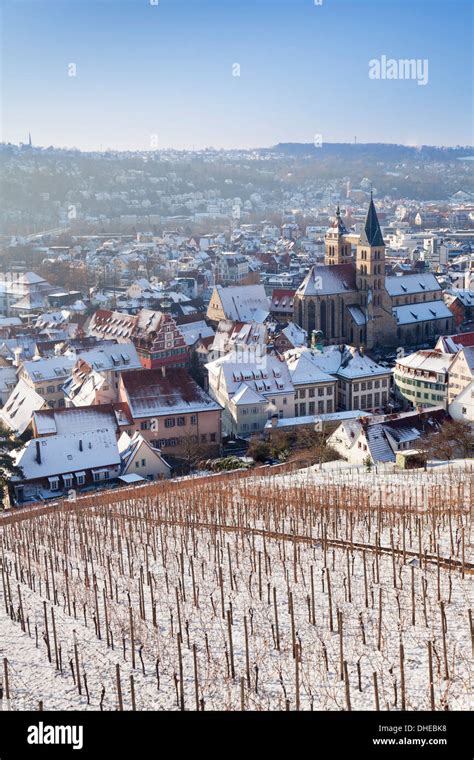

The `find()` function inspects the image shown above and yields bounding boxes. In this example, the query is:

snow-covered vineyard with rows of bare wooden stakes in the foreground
[0,468,474,710]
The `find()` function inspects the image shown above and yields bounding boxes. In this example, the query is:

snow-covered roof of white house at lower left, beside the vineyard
[13,428,120,481]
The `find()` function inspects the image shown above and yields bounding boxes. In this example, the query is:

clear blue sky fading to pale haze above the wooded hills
[0,0,473,150]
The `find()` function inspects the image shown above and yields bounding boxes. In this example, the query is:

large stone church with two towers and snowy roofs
[294,195,454,351]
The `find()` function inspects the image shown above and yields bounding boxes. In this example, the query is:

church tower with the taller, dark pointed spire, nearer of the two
[356,193,395,349]
